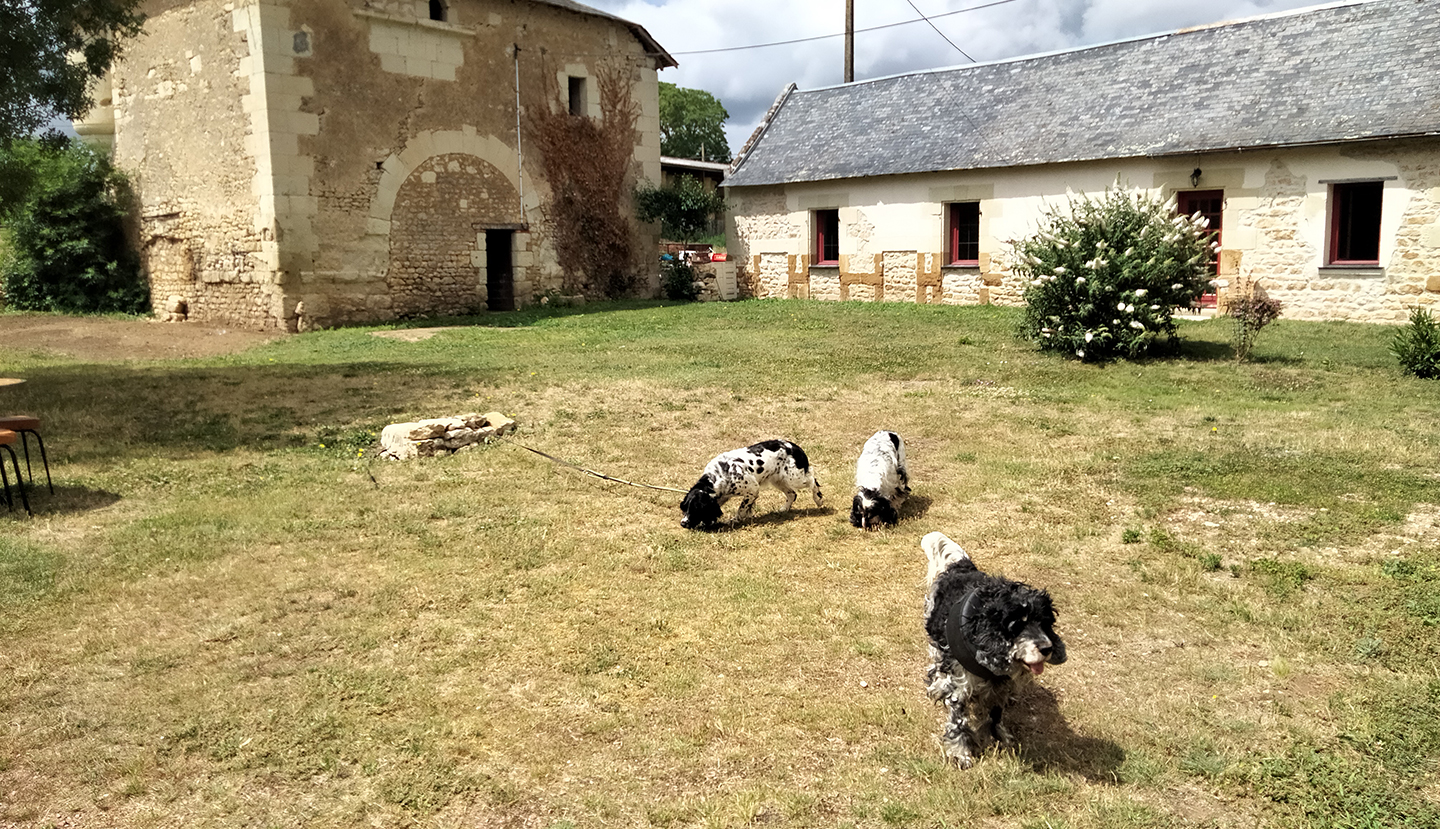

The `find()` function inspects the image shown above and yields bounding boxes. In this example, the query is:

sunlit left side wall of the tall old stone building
[97,0,281,328]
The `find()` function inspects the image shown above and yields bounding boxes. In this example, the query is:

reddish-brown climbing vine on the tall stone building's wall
[528,65,639,298]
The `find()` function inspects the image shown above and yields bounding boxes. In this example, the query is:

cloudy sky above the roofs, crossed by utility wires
[580,0,1336,153]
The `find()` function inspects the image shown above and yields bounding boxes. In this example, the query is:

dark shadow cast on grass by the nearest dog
[1007,682,1125,783]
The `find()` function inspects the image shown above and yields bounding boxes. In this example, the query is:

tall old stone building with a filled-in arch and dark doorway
[76,0,675,331]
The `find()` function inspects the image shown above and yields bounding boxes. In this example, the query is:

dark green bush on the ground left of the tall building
[0,138,150,314]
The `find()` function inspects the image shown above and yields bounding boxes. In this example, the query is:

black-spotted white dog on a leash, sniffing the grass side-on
[680,440,825,530]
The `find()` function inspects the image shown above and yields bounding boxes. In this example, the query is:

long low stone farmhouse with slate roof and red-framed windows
[724,0,1440,322]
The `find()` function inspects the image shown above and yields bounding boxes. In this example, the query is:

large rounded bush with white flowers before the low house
[1012,186,1214,361]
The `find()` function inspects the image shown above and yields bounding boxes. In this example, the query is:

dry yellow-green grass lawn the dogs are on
[0,301,1440,829]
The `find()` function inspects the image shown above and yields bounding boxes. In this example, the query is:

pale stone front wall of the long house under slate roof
[727,138,1440,322]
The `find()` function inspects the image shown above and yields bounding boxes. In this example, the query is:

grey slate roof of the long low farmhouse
[726,0,1440,187]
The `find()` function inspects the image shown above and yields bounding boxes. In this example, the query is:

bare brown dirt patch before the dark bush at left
[0,314,285,361]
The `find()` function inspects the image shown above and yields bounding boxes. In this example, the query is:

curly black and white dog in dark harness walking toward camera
[920,533,1066,769]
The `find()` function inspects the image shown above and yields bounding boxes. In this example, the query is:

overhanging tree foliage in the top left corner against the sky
[0,0,145,144]
